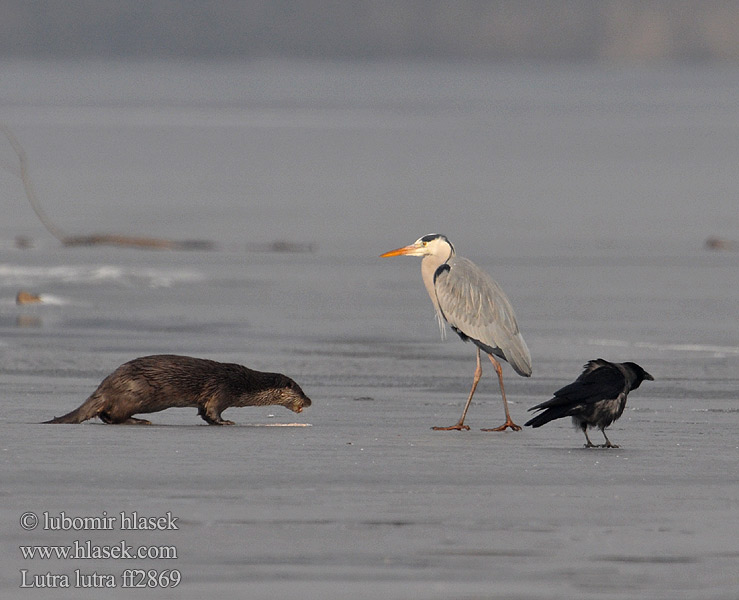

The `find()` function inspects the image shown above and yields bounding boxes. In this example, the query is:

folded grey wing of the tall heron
[434,257,531,376]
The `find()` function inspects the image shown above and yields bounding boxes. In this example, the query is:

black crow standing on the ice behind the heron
[525,358,654,448]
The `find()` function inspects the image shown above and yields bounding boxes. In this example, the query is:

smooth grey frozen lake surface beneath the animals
[0,61,739,600]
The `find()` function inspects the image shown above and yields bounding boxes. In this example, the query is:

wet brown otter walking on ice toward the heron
[45,354,311,425]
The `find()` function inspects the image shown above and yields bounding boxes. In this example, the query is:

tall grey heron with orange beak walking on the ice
[381,233,531,431]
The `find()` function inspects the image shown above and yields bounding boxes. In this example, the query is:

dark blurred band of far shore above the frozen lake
[5,0,739,61]
